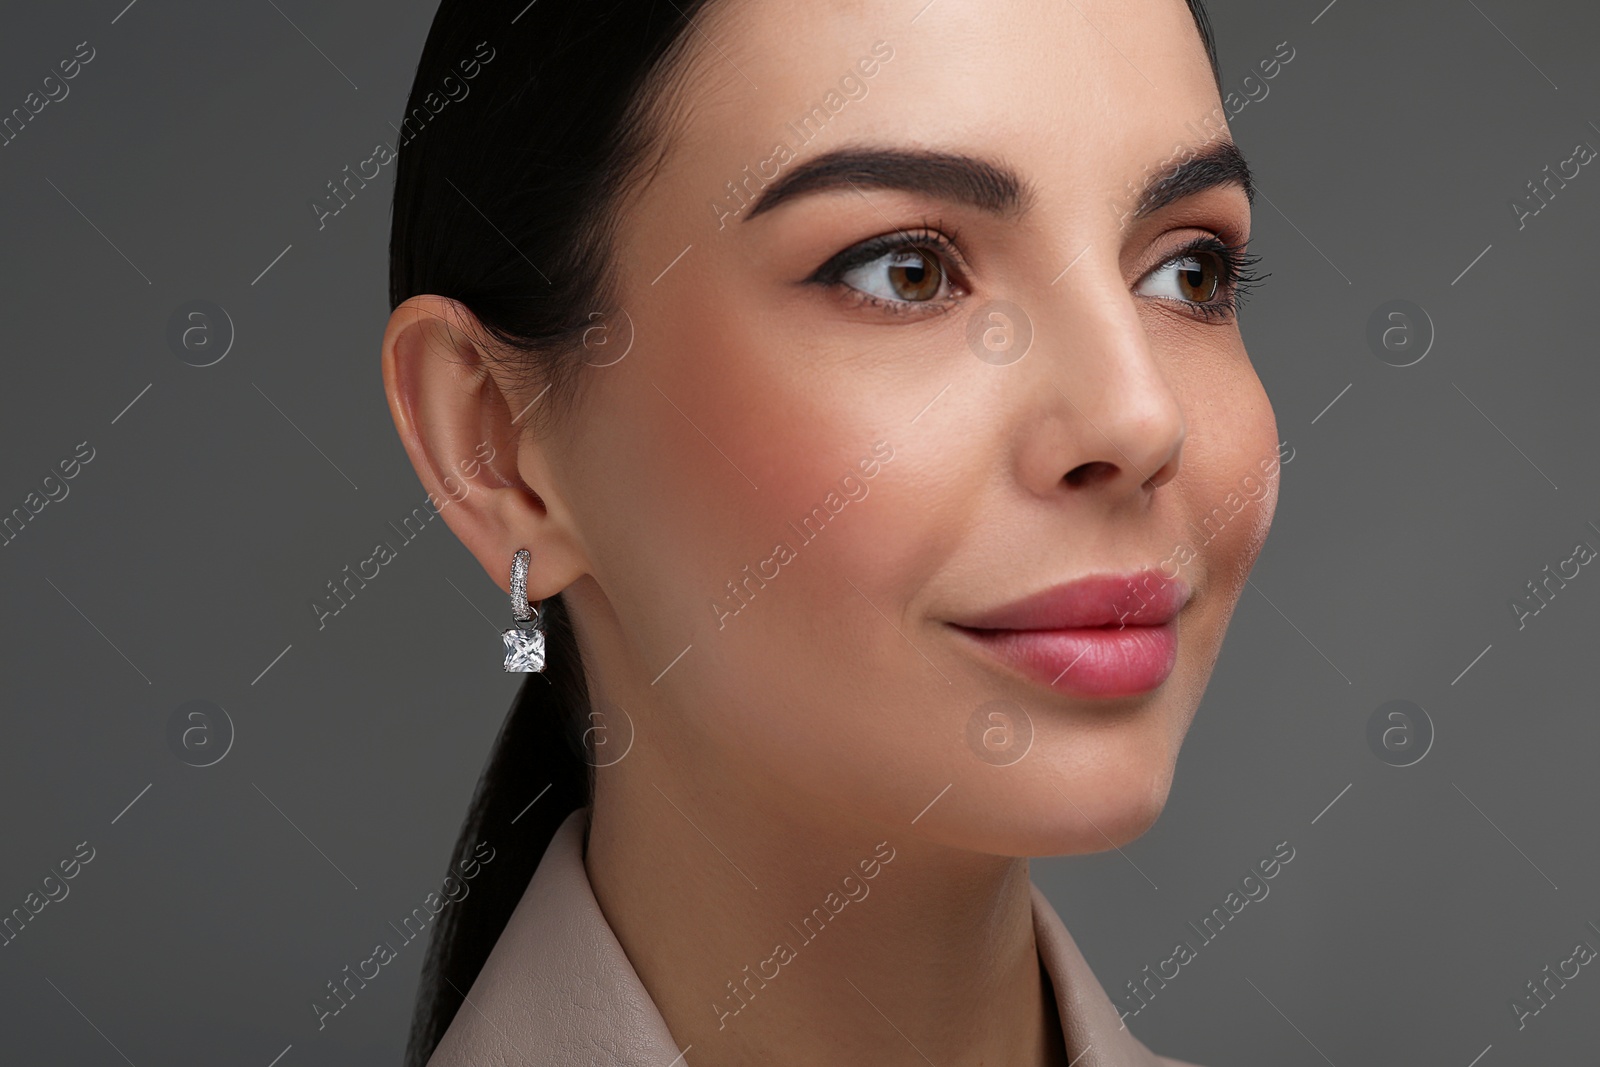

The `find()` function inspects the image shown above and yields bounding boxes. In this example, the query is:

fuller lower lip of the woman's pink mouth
[957,619,1178,696]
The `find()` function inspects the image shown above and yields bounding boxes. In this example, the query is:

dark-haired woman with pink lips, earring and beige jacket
[382,0,1278,1067]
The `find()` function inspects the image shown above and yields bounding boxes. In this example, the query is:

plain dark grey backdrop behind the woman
[0,0,1600,1067]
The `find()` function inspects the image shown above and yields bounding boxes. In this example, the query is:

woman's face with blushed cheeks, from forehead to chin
[542,0,1278,856]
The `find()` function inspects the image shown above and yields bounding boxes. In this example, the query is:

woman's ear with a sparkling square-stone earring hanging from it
[382,296,589,601]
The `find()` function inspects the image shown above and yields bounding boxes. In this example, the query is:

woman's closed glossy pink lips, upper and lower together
[954,569,1190,696]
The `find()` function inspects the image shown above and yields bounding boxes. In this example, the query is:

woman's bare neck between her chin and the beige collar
[586,752,1066,1067]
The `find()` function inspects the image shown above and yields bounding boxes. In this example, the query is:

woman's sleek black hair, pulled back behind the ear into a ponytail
[389,0,709,1067]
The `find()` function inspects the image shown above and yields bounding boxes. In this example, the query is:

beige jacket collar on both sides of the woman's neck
[427,808,1195,1067]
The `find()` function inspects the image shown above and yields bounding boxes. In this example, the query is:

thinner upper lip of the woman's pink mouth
[957,568,1190,630]
